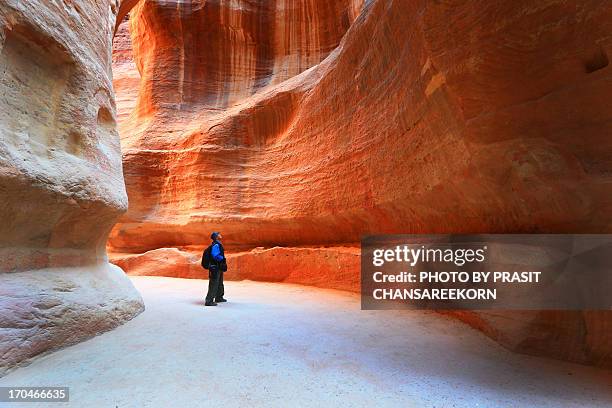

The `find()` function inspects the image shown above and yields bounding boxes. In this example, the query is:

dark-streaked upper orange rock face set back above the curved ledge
[131,0,360,116]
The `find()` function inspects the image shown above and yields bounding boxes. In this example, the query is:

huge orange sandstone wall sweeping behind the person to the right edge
[109,0,612,366]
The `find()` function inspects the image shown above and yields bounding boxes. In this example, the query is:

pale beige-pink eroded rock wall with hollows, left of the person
[0,0,143,375]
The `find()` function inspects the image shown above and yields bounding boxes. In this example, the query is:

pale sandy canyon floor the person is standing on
[0,277,612,408]
